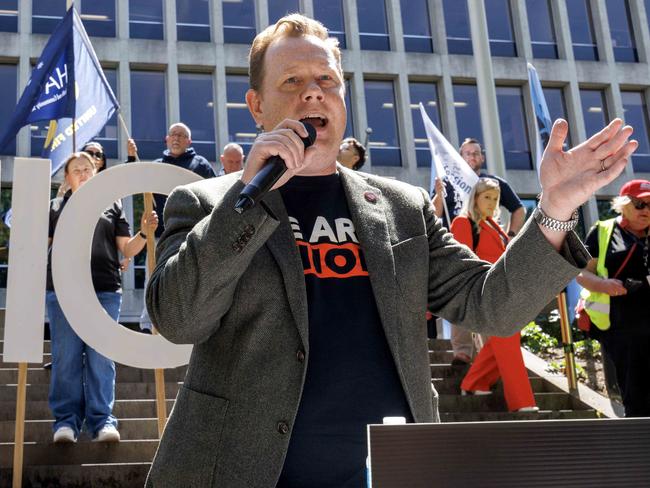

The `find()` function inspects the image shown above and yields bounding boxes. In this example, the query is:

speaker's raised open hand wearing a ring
[540,119,639,220]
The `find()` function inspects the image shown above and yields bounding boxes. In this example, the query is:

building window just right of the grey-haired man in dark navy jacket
[178,73,217,161]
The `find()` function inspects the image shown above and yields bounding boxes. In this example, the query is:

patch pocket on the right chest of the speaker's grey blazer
[393,235,429,312]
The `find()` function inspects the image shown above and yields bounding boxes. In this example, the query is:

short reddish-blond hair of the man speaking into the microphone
[248,14,343,92]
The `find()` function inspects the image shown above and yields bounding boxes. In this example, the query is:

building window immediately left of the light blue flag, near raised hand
[497,86,533,169]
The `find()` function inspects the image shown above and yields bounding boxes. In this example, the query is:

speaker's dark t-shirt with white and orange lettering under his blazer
[277,174,412,488]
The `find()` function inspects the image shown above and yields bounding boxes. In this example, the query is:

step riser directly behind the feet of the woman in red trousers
[439,392,586,413]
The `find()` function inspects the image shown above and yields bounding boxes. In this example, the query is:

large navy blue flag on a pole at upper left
[0,7,119,174]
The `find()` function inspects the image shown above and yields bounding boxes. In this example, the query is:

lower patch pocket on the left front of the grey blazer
[147,386,228,487]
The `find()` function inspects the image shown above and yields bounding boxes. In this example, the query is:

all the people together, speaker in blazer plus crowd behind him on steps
[41,14,650,487]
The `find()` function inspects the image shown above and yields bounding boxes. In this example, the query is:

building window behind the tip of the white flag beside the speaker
[409,81,442,167]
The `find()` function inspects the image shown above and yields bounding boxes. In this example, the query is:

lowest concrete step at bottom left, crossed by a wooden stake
[0,463,151,488]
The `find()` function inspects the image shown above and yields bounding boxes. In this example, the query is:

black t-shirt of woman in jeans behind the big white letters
[47,191,131,292]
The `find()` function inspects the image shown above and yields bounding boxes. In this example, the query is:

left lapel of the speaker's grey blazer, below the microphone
[263,191,309,352]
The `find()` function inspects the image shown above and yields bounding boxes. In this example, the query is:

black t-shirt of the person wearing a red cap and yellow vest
[585,220,650,338]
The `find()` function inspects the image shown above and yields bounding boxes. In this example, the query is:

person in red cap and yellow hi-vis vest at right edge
[578,180,650,417]
